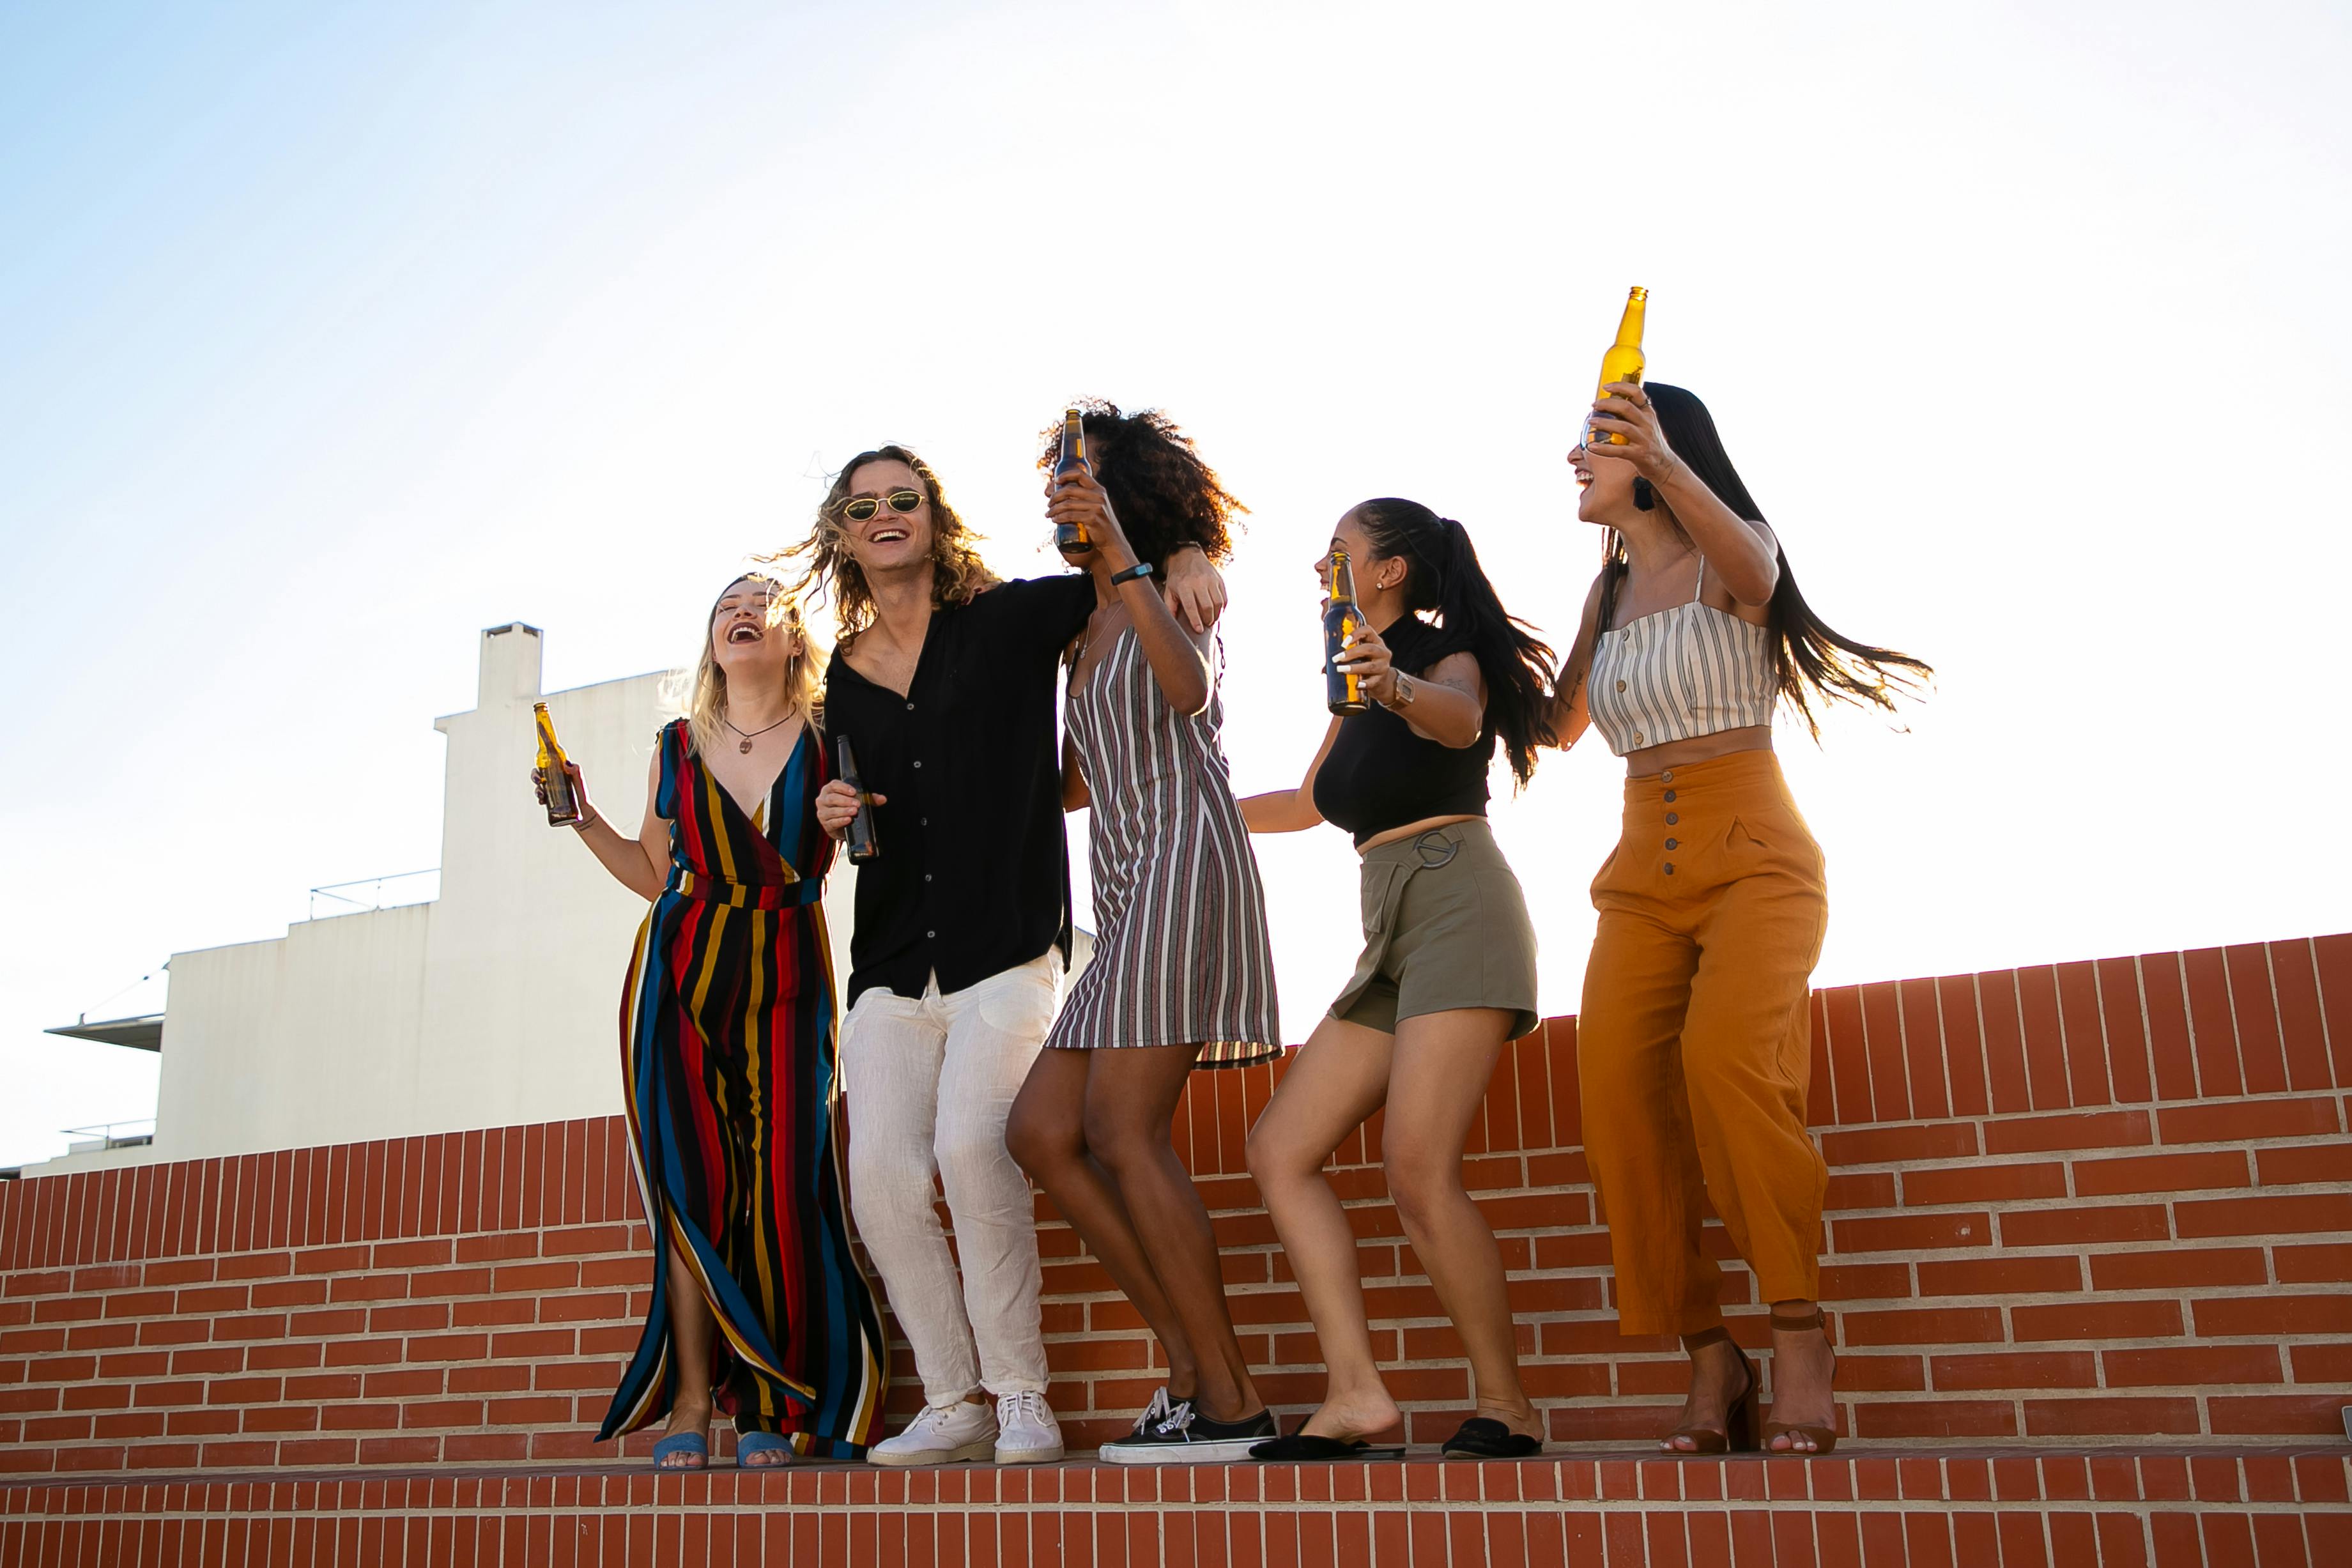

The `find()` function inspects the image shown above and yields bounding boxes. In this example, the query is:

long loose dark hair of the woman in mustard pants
[1595,381,1935,741]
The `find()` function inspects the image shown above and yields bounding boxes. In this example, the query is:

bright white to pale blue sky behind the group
[0,0,2352,1164]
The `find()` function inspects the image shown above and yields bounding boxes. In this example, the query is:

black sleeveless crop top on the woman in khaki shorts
[1315,613,1493,849]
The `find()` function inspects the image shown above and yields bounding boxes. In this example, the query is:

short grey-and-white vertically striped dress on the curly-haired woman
[1044,627,1282,1067]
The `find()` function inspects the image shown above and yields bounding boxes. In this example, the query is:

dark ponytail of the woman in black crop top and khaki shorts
[1355,496,1557,785]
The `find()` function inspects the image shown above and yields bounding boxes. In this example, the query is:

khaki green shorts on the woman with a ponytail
[1331,818,1543,1039]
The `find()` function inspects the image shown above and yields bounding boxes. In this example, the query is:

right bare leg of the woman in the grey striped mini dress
[1087,1046,1265,1420]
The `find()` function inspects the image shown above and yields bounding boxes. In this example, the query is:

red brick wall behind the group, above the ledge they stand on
[0,935,2352,1472]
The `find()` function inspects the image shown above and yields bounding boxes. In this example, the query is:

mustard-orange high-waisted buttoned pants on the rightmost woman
[1576,750,1830,1335]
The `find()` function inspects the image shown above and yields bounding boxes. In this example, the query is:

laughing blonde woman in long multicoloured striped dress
[538,576,887,1469]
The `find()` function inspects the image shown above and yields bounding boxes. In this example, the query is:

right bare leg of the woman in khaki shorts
[1381,1006,1543,1439]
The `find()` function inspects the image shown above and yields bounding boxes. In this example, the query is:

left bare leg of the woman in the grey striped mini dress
[1004,1051,1199,1399]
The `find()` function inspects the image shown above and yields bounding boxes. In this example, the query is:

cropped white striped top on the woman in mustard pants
[1585,557,1781,757]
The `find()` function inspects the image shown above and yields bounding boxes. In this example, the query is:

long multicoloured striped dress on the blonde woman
[597,719,889,1460]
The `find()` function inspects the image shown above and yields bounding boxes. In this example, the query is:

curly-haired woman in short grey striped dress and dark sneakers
[1006,404,1282,1464]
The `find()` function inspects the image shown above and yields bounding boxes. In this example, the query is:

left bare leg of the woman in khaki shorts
[1249,1018,1399,1441]
